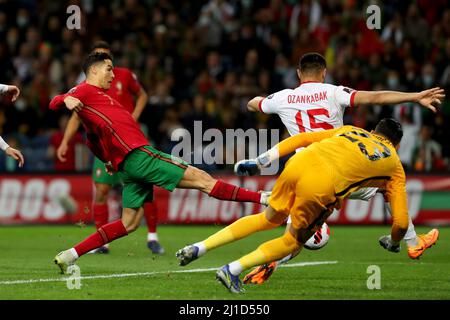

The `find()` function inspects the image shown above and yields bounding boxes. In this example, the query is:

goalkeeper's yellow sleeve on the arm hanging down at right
[386,160,409,241]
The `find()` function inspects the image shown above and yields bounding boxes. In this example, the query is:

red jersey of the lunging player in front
[50,83,150,171]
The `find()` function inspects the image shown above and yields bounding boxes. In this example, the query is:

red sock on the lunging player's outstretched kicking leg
[209,180,261,203]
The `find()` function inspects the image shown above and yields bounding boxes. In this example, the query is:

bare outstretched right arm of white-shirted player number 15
[354,87,445,112]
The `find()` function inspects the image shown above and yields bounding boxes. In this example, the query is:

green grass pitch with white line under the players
[0,225,450,300]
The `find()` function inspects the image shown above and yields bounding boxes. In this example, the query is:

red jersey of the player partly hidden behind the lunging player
[106,67,141,113]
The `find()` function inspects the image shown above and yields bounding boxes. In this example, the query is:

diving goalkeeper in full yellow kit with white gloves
[176,119,418,293]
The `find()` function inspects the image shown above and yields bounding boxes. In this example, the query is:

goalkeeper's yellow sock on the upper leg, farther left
[203,212,278,250]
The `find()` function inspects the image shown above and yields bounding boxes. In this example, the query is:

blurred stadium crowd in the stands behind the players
[0,0,450,172]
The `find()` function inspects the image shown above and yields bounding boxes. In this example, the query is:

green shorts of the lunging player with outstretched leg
[119,146,188,208]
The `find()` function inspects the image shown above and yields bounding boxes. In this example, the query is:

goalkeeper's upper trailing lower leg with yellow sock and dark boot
[175,207,285,266]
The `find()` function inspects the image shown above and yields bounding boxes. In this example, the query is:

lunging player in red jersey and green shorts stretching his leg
[50,53,268,273]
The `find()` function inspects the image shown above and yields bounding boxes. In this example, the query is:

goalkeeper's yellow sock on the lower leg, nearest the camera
[238,232,301,270]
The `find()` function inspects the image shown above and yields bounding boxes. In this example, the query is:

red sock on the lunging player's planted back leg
[74,220,128,257]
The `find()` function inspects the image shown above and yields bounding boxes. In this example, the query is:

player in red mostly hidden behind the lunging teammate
[57,41,164,254]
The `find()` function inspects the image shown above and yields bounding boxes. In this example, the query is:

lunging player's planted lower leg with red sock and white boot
[54,208,144,273]
